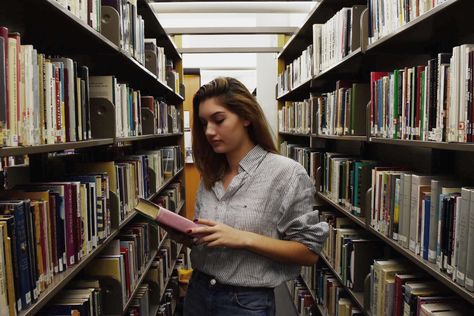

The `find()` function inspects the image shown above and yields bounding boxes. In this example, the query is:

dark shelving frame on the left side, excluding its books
[0,0,185,316]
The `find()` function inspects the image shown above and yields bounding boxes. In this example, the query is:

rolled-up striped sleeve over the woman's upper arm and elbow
[277,169,329,254]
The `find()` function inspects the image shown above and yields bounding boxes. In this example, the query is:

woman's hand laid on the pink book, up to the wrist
[189,219,249,248]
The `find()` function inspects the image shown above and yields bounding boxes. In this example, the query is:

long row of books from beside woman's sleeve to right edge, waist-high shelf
[322,153,474,291]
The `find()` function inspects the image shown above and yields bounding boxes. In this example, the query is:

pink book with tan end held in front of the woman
[135,198,201,235]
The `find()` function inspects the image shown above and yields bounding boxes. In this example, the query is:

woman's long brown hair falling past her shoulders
[192,77,277,189]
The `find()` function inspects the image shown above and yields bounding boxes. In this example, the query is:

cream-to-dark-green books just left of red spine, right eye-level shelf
[311,80,370,135]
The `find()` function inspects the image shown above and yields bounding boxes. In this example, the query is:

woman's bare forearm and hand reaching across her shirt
[190,219,319,265]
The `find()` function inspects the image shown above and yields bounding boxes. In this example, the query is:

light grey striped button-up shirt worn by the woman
[191,146,328,287]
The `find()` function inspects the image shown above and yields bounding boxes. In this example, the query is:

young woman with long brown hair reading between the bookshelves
[184,78,328,316]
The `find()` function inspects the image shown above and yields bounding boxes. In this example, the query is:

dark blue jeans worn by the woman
[183,270,275,316]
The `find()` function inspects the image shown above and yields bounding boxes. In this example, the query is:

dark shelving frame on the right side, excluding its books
[277,0,474,315]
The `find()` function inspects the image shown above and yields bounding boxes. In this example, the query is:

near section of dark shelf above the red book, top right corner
[367,0,468,55]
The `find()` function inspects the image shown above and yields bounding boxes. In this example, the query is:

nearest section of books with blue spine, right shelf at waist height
[371,167,474,291]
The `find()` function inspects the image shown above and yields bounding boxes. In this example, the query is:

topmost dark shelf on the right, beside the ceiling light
[278,0,367,62]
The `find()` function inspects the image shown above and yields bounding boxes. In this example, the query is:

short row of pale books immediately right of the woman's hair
[278,99,313,134]
